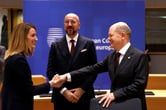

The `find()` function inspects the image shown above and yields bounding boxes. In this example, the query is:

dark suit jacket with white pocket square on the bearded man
[47,35,97,110]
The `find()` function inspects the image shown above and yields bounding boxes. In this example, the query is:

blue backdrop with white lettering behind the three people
[23,0,145,89]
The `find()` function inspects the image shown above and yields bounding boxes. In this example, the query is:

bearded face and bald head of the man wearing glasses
[64,13,80,38]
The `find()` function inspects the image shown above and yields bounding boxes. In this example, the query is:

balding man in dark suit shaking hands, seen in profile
[52,22,148,110]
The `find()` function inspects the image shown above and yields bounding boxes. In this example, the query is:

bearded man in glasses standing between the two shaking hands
[47,13,97,110]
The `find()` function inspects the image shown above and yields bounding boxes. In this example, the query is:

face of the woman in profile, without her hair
[27,28,38,50]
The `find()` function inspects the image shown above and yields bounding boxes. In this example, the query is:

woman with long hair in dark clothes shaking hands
[2,23,53,110]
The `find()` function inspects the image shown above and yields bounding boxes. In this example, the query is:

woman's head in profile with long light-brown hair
[5,23,38,59]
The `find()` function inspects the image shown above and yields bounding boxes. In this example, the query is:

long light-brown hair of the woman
[5,23,36,59]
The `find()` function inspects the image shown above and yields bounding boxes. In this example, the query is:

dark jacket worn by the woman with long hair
[2,54,50,110]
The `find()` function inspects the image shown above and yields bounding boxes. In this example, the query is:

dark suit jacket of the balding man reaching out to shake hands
[71,46,148,110]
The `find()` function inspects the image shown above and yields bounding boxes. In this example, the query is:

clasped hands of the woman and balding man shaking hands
[49,74,67,88]
